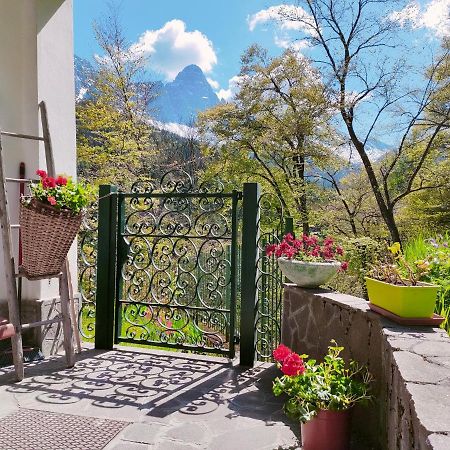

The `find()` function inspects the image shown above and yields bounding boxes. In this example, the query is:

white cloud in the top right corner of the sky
[388,0,450,37]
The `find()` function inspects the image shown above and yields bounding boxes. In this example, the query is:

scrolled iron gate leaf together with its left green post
[96,170,241,357]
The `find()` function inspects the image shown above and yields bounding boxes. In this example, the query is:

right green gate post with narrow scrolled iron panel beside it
[240,183,293,366]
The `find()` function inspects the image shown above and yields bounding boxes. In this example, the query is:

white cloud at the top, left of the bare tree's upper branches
[247,5,314,35]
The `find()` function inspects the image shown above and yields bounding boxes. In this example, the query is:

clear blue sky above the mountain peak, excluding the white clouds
[74,0,279,98]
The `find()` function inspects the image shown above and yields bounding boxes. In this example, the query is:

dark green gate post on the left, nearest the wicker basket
[95,185,117,350]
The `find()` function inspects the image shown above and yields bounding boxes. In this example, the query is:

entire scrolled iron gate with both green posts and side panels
[88,177,293,365]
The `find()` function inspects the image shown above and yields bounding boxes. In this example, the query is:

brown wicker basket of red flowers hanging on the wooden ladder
[19,170,91,279]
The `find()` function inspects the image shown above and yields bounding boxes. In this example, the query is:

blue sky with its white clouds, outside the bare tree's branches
[74,0,450,102]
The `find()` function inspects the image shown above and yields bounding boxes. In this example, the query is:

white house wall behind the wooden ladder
[0,0,76,301]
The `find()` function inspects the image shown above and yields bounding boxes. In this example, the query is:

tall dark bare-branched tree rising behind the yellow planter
[280,0,450,242]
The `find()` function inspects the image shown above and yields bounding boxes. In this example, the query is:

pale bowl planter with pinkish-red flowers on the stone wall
[266,233,348,288]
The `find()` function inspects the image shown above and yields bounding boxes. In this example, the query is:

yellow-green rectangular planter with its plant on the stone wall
[366,242,439,318]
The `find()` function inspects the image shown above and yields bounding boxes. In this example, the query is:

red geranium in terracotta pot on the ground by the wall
[273,341,372,450]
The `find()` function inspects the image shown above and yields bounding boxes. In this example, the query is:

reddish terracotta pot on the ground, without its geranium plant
[301,410,350,450]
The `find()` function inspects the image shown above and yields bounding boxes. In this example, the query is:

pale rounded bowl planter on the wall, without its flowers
[277,257,341,288]
